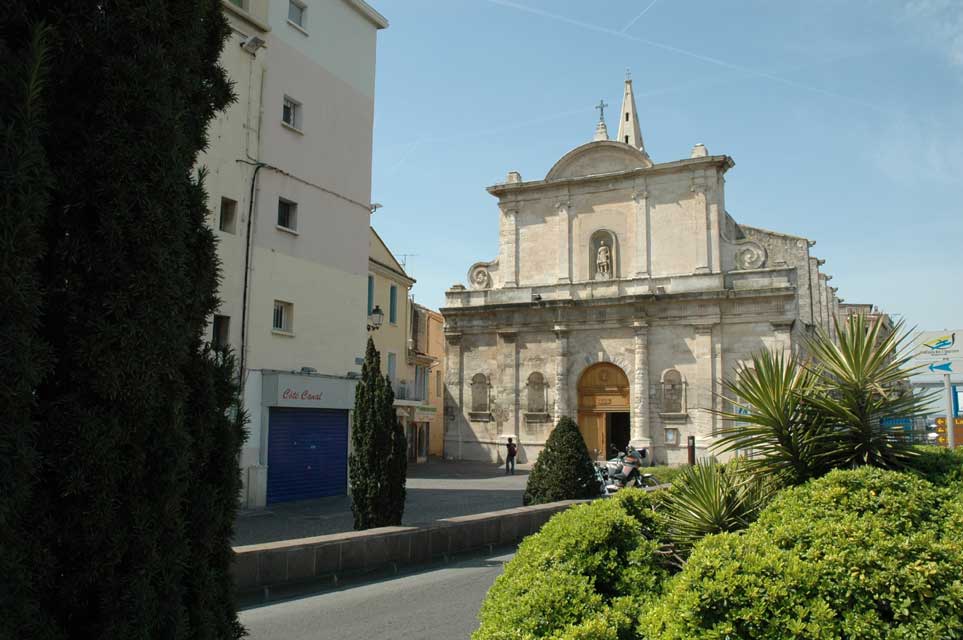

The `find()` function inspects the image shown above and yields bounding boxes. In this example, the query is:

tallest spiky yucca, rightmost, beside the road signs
[806,314,927,469]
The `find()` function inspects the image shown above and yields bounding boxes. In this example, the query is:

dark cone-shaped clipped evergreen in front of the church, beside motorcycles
[522,416,599,504]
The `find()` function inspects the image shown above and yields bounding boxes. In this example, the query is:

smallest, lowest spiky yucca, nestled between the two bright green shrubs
[661,459,770,554]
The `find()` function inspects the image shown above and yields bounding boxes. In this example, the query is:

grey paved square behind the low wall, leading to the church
[233,459,531,546]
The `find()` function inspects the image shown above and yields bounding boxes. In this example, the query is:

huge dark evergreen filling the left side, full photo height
[0,0,241,638]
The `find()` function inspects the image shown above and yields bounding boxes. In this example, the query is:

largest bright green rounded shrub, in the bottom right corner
[639,468,963,640]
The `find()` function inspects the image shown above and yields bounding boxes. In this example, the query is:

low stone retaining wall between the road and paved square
[232,500,590,599]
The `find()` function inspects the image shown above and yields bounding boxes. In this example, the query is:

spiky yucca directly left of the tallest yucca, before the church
[713,350,829,484]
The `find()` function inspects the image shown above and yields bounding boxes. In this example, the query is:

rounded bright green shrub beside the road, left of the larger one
[472,490,667,640]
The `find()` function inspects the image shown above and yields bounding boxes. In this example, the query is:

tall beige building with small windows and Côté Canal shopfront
[199,0,387,507]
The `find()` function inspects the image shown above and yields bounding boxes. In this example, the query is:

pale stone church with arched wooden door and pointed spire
[441,79,841,464]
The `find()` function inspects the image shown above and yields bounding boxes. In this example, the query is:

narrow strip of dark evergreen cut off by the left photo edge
[0,17,55,638]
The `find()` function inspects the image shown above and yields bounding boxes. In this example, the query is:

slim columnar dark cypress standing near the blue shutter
[348,338,408,529]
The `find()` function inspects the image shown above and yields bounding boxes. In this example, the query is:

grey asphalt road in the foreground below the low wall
[240,551,514,640]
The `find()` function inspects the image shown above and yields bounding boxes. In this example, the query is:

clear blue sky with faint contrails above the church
[372,0,963,329]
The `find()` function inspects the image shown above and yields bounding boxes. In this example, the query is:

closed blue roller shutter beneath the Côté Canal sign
[267,407,348,504]
